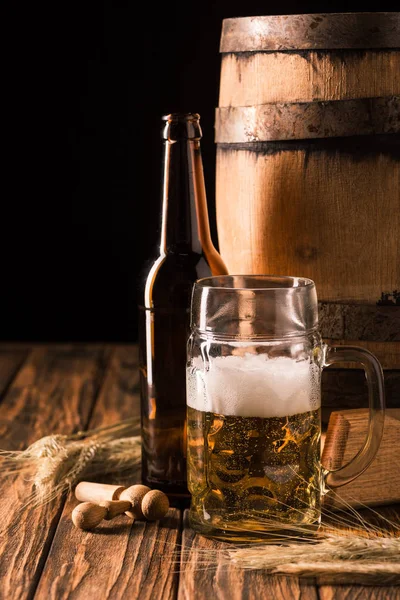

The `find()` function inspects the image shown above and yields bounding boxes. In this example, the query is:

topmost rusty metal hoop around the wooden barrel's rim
[220,12,400,53]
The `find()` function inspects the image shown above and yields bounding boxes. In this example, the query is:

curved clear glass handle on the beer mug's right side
[323,346,385,488]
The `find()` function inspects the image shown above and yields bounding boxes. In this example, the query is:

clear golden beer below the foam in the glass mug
[187,407,321,538]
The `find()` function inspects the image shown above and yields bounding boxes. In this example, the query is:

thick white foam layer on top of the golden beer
[186,353,321,418]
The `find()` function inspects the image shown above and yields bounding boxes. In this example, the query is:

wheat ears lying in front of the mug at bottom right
[184,490,400,585]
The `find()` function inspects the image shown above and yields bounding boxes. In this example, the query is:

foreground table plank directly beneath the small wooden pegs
[35,497,180,600]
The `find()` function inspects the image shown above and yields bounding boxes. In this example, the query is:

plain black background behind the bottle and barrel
[0,0,393,342]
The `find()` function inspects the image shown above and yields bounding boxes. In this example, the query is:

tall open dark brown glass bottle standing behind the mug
[139,113,227,499]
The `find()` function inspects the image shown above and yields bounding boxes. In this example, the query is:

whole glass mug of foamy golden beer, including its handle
[186,275,384,541]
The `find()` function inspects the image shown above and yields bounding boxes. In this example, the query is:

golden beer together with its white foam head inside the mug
[187,355,321,539]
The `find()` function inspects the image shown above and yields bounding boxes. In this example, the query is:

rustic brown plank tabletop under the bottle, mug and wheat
[0,344,400,600]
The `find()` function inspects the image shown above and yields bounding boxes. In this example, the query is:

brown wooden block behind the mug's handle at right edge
[322,408,400,509]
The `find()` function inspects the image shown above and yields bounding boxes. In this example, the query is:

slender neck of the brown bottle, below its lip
[161,139,211,254]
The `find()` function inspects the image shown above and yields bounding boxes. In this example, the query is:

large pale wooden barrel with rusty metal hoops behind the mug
[215,12,400,403]
